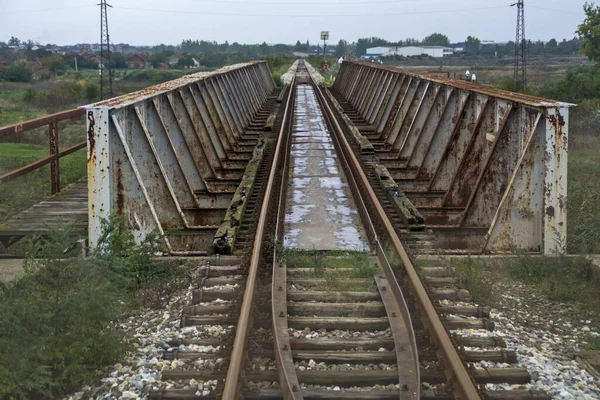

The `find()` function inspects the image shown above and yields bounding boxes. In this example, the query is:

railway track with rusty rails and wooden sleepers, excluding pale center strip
[152,63,548,399]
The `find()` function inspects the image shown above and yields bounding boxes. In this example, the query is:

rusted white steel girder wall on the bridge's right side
[333,62,572,254]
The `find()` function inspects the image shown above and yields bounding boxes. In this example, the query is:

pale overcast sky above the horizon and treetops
[0,0,585,45]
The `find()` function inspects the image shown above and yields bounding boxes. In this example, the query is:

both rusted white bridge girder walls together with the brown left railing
[0,62,571,255]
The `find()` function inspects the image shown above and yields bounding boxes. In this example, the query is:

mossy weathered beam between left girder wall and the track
[213,139,265,254]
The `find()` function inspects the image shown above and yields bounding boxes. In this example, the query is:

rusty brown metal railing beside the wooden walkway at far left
[0,108,87,194]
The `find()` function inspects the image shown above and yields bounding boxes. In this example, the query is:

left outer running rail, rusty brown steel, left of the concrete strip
[222,74,293,400]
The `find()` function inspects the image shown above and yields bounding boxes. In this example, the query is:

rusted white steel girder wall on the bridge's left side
[84,62,274,254]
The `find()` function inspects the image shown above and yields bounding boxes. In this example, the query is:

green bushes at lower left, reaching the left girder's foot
[0,215,191,399]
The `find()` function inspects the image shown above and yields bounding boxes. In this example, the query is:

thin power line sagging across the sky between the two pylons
[118,3,507,18]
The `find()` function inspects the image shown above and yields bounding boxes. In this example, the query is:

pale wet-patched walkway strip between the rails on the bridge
[285,85,368,251]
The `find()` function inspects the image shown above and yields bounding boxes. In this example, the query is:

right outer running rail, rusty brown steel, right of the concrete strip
[317,77,480,399]
